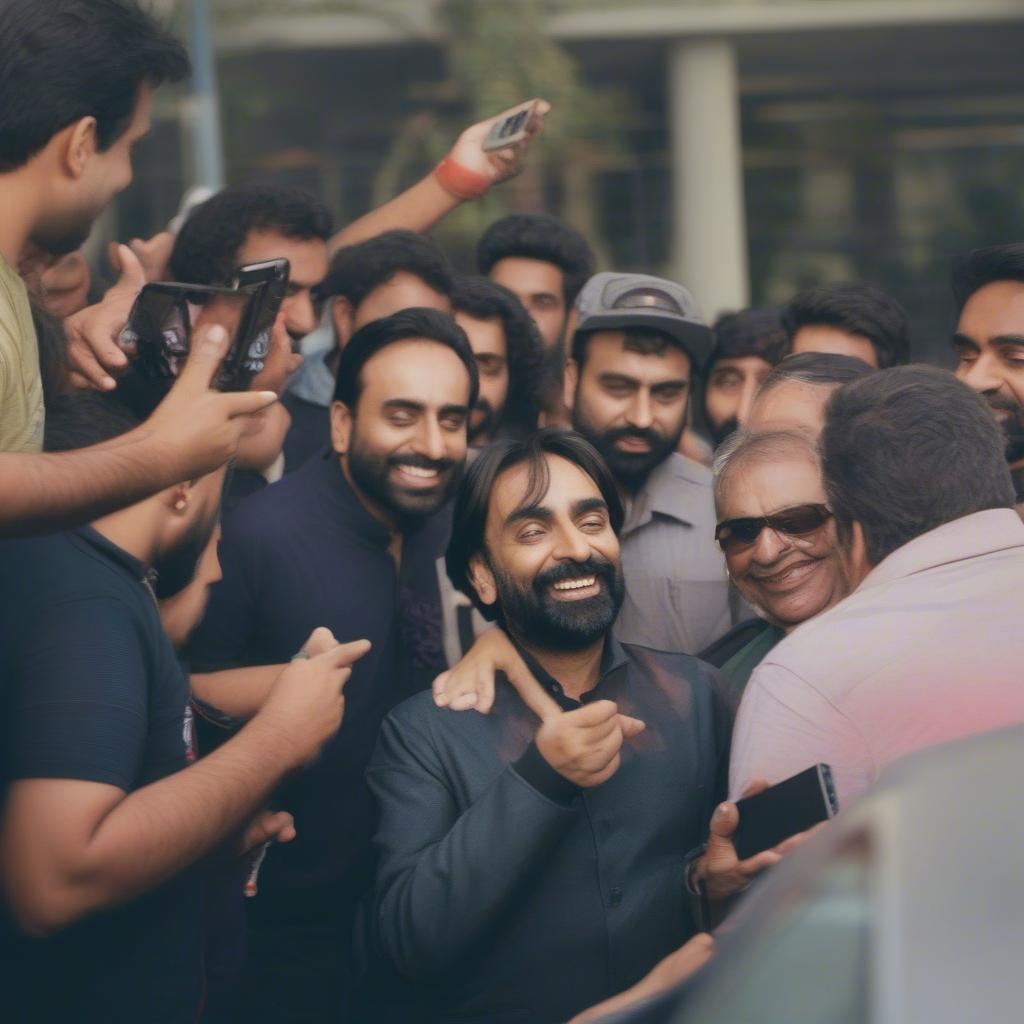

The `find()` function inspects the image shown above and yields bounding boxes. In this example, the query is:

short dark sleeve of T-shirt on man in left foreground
[5,597,148,792]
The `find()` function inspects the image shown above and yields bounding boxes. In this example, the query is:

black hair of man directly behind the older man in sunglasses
[782,281,910,370]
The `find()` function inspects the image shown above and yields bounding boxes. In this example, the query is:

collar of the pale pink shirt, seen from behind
[857,509,1024,590]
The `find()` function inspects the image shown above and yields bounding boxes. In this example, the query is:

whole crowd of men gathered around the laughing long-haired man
[0,0,1024,1024]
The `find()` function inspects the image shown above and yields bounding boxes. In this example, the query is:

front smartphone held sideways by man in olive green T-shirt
[120,283,260,391]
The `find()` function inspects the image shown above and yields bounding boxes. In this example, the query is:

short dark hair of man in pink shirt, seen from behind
[820,367,1014,565]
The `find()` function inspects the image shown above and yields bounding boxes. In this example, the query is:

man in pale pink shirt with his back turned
[729,367,1024,806]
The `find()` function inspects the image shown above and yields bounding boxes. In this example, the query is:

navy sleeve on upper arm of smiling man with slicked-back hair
[186,510,263,672]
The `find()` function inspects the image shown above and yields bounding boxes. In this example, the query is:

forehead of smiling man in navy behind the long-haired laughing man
[359,338,469,408]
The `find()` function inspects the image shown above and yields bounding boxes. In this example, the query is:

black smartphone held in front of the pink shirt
[732,765,839,860]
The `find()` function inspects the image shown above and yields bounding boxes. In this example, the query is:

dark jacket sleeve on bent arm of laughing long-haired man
[367,715,577,980]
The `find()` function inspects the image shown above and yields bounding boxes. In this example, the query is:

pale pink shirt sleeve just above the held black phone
[729,664,873,808]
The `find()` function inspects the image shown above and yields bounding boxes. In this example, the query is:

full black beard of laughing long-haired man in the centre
[488,555,625,650]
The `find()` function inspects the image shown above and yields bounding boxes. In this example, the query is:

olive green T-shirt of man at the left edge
[0,256,45,452]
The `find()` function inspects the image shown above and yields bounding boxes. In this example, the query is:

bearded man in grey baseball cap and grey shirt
[565,273,738,653]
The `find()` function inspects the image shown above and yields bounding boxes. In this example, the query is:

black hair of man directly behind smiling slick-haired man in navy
[317,230,455,308]
